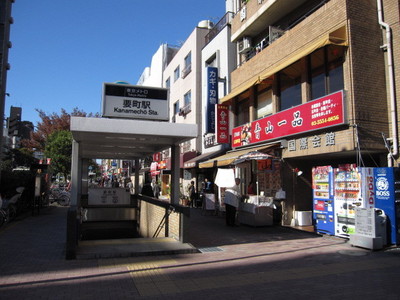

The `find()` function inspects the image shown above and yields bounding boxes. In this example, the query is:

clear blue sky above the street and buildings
[5,0,225,125]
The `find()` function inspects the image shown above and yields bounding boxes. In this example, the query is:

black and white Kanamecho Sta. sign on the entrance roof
[102,83,169,121]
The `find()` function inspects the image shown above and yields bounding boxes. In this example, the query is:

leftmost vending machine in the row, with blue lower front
[312,166,335,235]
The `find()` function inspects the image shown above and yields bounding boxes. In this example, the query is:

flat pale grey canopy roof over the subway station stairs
[70,117,198,160]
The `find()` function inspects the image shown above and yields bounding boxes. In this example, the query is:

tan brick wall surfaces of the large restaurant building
[232,0,392,157]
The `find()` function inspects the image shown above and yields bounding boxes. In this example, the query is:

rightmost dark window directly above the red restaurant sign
[309,46,344,99]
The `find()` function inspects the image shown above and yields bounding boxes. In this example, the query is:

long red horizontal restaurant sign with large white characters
[232,91,346,147]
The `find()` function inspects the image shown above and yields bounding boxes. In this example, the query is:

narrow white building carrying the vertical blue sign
[184,7,236,191]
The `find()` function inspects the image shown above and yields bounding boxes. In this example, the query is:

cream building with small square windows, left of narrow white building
[156,21,212,192]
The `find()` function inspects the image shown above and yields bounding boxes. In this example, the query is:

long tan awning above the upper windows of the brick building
[220,26,348,104]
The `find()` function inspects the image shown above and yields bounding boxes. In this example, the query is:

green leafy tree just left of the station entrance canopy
[44,130,72,178]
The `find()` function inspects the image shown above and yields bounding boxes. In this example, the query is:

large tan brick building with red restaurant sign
[200,0,400,225]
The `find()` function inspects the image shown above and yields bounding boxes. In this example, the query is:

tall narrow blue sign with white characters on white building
[205,67,218,133]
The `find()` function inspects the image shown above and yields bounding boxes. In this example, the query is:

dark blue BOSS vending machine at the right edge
[374,168,400,245]
